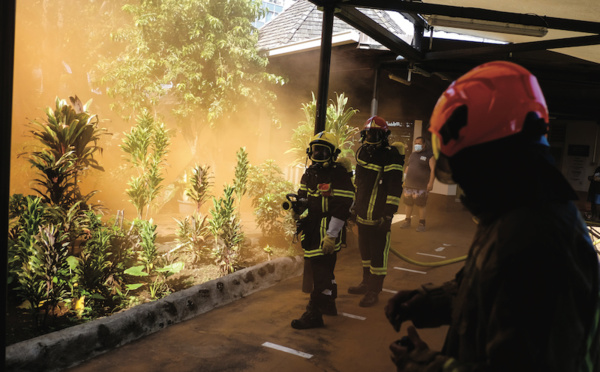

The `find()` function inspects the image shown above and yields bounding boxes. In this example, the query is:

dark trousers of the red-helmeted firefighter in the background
[357,223,390,293]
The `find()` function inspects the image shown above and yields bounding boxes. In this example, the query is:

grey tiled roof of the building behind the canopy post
[258,0,405,50]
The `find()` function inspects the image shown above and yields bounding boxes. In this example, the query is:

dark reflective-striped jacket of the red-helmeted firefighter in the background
[354,145,404,225]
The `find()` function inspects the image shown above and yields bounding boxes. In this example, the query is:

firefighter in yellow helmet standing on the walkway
[292,132,354,329]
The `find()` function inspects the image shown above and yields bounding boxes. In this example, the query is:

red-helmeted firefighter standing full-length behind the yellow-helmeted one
[348,116,404,307]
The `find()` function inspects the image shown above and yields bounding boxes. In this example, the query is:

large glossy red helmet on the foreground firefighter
[429,61,548,158]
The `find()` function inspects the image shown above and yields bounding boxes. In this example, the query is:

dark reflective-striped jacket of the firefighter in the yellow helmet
[298,162,354,258]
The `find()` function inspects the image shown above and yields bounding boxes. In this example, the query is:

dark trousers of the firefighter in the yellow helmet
[307,253,337,312]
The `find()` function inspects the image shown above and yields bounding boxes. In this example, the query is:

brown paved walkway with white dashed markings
[68,201,475,372]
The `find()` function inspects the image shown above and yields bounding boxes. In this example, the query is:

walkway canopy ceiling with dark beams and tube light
[309,0,600,121]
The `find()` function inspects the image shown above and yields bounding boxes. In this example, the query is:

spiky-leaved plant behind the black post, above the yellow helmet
[286,93,359,164]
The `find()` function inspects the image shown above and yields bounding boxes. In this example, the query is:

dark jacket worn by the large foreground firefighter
[415,201,600,372]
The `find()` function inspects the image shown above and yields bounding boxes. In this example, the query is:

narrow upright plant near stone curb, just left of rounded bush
[209,185,244,274]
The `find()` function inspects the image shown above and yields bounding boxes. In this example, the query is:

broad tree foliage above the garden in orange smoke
[100,0,283,123]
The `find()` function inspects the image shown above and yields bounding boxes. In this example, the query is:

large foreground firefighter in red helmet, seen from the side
[385,61,600,372]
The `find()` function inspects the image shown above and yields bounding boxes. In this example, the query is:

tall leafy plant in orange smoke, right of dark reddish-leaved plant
[121,110,170,219]
